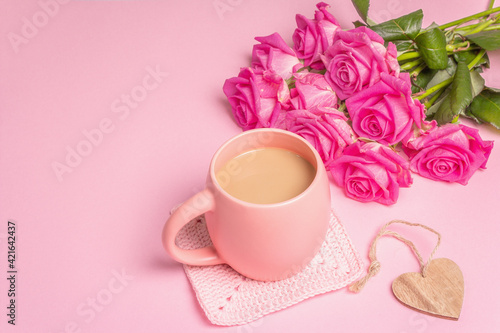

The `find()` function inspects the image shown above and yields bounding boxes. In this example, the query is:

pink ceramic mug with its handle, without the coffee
[162,128,330,281]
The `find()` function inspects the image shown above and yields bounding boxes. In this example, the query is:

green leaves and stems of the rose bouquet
[352,0,500,129]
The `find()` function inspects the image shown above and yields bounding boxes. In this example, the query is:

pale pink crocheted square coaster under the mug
[176,212,363,326]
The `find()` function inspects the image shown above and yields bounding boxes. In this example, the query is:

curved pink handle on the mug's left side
[162,189,224,266]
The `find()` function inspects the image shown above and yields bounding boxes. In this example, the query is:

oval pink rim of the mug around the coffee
[209,128,324,208]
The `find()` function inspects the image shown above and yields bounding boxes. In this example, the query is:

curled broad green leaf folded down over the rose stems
[415,28,448,69]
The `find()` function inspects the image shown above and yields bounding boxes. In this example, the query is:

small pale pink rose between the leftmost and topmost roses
[252,33,301,80]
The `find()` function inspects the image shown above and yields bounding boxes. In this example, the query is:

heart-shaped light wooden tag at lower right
[392,258,464,320]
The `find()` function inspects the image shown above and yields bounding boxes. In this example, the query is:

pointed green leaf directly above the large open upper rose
[370,9,424,42]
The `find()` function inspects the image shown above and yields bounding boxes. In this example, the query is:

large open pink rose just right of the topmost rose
[321,27,399,100]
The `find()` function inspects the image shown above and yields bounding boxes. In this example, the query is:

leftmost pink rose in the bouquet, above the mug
[223,67,290,131]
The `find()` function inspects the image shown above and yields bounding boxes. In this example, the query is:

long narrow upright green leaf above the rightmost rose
[434,61,474,125]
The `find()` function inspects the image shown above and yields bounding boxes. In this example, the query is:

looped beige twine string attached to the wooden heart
[349,220,441,293]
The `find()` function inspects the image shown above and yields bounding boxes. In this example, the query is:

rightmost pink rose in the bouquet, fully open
[404,122,493,185]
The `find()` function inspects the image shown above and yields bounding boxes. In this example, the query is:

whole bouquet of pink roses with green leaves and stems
[223,0,500,205]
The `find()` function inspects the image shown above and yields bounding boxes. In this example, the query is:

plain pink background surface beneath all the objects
[0,0,500,333]
